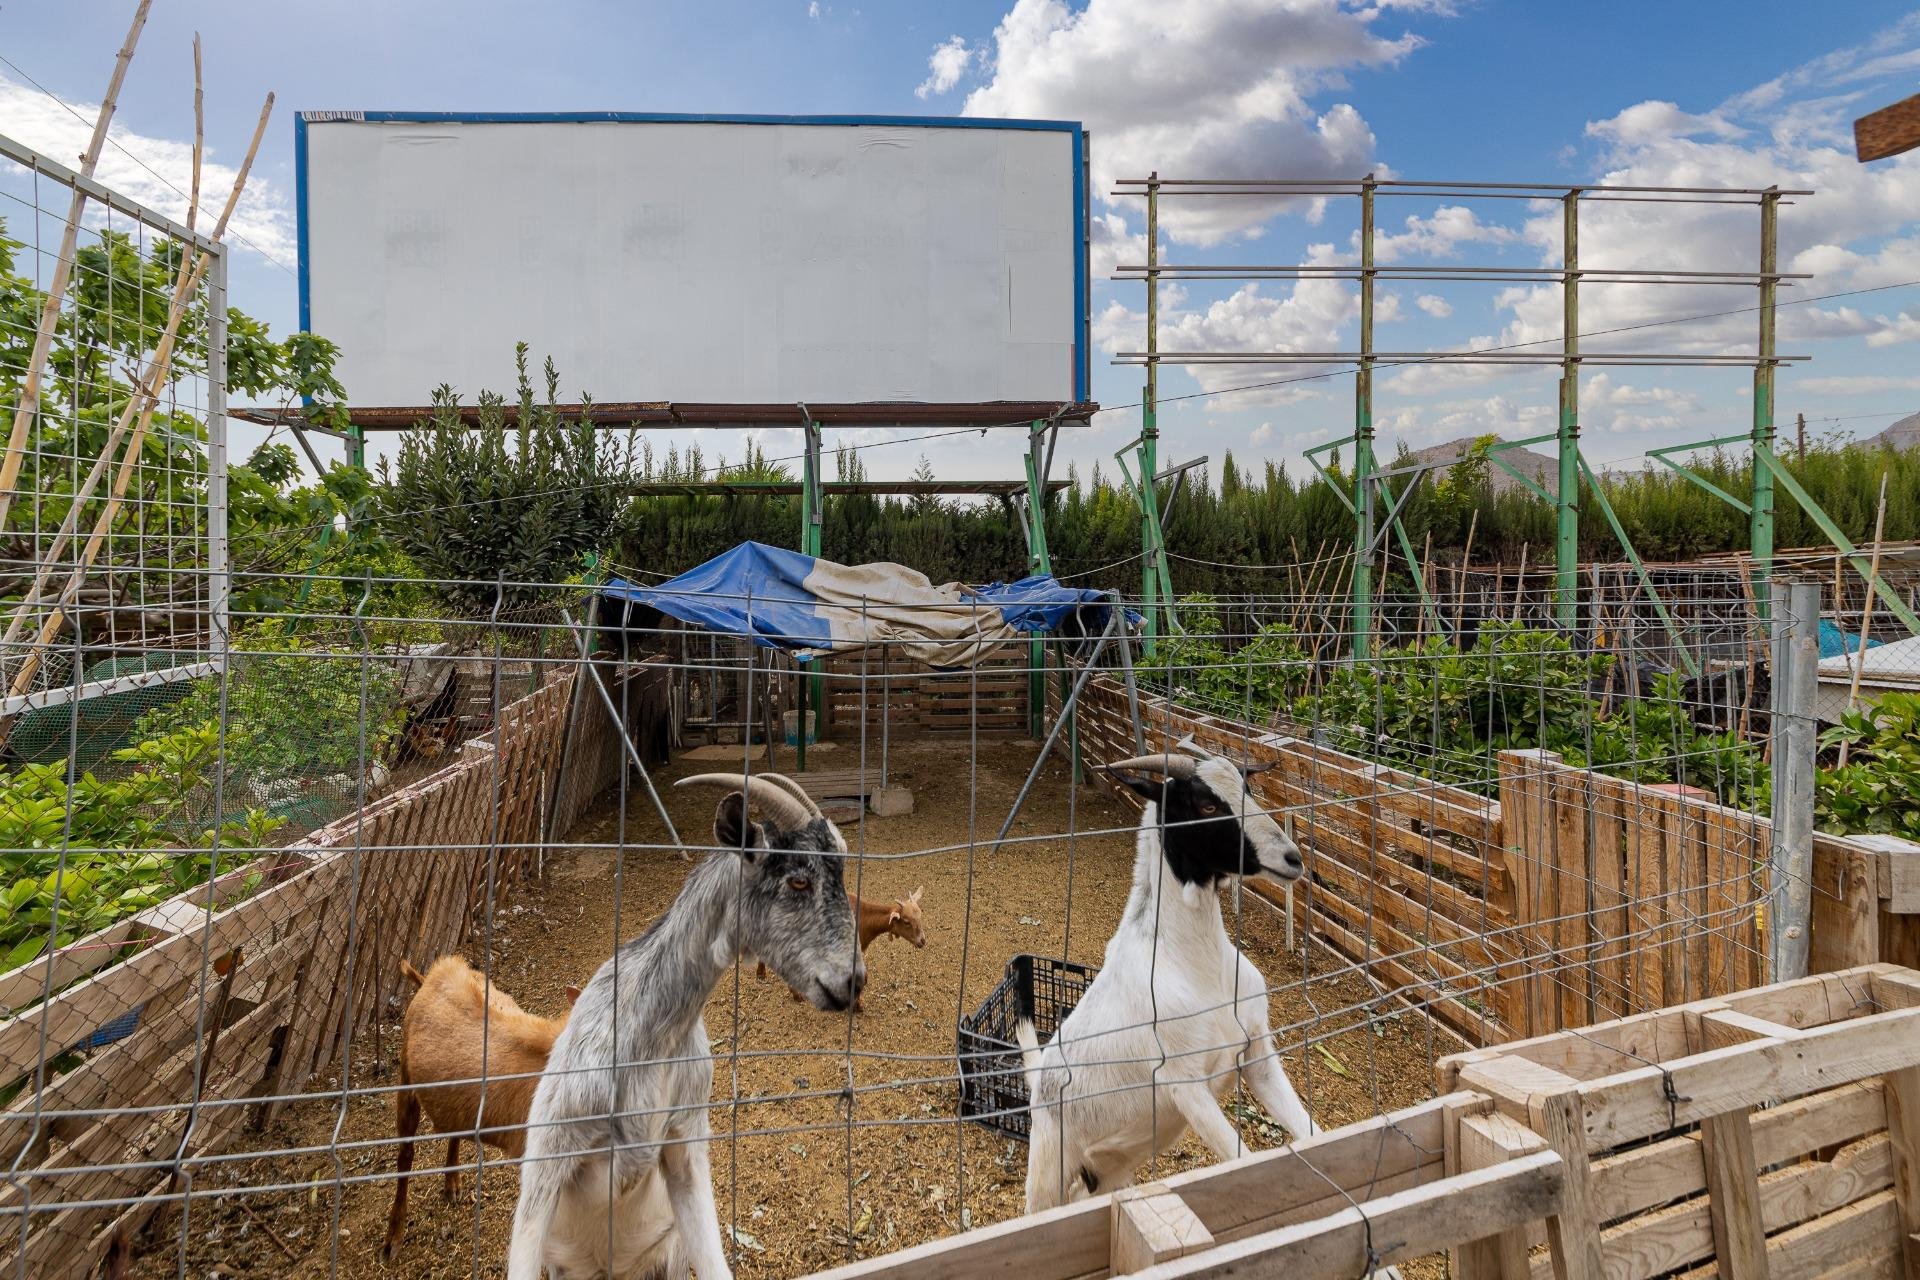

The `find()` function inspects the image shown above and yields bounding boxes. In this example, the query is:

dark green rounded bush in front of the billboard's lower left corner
[380,342,624,612]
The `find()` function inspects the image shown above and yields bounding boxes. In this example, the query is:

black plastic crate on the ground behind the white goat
[958,956,1098,1142]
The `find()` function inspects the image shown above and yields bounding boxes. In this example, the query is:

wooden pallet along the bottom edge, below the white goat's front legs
[816,1094,1597,1280]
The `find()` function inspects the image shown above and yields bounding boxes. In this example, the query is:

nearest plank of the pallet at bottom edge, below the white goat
[1121,1151,1584,1280]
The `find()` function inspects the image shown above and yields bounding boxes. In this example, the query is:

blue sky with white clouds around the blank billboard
[0,0,1920,485]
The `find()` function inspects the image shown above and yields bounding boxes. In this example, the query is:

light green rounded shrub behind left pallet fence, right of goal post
[134,626,405,787]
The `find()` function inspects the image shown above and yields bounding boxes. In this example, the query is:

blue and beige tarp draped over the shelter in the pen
[601,543,1133,668]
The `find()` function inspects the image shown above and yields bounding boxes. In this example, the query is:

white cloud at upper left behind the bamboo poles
[0,75,296,265]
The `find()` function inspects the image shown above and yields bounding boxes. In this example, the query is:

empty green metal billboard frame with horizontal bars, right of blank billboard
[1112,173,1920,670]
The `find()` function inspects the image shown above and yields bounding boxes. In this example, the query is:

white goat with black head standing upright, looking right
[1016,743,1315,1213]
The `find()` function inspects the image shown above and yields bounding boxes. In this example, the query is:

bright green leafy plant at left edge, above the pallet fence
[0,725,282,973]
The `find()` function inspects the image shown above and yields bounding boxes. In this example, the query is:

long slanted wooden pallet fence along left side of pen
[0,668,666,1278]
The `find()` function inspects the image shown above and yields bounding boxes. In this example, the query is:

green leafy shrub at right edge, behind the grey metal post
[1814,693,1920,841]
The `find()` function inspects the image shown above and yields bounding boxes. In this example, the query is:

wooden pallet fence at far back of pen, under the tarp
[822,645,1031,750]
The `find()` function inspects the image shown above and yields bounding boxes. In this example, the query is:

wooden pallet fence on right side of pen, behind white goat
[1048,677,1781,1044]
